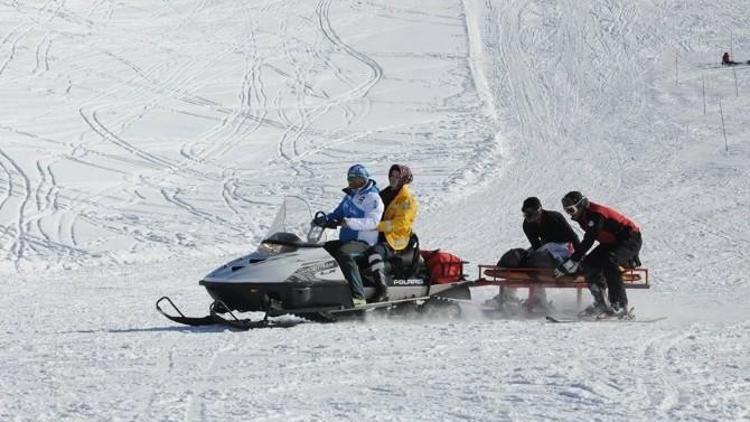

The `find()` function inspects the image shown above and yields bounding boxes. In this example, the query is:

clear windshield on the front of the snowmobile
[258,196,326,255]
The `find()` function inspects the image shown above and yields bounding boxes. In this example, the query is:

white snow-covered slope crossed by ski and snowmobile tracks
[0,0,750,421]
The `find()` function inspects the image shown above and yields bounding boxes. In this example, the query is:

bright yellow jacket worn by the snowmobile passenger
[378,185,417,251]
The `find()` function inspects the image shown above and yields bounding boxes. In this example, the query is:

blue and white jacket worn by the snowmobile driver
[326,180,384,246]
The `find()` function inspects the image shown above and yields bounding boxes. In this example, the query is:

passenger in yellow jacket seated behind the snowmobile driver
[368,164,417,302]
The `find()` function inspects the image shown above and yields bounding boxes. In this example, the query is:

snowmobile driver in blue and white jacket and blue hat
[313,164,383,306]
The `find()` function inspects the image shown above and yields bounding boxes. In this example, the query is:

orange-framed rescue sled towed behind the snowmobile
[474,265,651,312]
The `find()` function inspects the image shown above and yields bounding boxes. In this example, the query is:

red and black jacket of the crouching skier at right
[571,202,641,261]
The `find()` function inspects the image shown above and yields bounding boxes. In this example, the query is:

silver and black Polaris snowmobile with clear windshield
[156,197,471,329]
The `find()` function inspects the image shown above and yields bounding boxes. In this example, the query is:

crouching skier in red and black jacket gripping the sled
[555,191,642,317]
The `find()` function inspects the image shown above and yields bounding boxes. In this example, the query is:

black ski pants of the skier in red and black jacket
[582,232,642,308]
